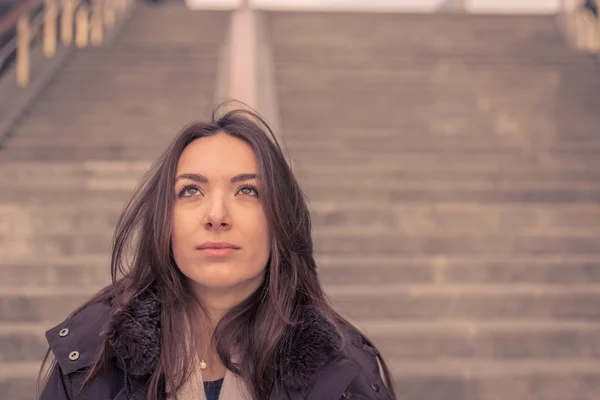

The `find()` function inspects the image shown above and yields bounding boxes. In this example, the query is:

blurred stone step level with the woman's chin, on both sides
[0,253,600,292]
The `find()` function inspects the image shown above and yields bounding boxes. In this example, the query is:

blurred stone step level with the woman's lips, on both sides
[0,228,600,260]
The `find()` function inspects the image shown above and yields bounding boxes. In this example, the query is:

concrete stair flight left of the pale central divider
[0,1,229,400]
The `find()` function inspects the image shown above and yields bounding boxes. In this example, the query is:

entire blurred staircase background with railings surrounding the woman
[0,0,600,400]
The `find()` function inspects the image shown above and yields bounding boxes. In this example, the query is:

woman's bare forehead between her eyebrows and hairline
[177,133,258,177]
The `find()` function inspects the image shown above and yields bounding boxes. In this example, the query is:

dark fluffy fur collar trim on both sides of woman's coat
[105,290,343,390]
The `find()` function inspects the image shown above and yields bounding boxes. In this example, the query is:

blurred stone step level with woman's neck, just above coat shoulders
[0,283,600,324]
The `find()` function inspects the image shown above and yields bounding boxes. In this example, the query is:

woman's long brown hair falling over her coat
[36,104,394,400]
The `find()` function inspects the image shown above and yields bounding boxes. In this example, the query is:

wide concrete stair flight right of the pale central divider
[269,12,600,400]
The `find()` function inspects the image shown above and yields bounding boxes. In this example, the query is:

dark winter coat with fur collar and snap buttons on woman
[41,288,392,400]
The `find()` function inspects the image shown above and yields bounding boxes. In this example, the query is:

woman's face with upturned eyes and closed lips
[172,133,270,298]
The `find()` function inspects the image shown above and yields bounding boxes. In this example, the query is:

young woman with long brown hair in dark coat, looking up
[41,109,395,400]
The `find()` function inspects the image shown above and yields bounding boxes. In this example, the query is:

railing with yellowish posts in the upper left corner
[0,0,133,88]
